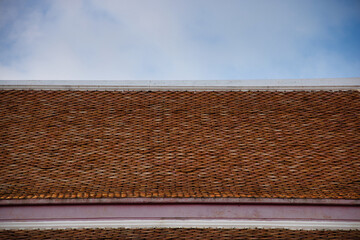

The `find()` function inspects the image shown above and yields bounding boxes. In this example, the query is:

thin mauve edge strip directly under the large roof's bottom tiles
[0,198,360,206]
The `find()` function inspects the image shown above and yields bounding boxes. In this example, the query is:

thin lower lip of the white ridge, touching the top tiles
[0,85,360,91]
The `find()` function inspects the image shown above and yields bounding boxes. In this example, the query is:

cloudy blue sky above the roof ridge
[0,0,360,80]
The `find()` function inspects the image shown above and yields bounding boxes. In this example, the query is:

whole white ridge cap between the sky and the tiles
[0,78,360,91]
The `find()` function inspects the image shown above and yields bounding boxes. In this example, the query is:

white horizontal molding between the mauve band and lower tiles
[0,219,360,230]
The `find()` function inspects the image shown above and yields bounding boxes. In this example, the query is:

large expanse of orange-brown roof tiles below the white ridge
[0,90,360,199]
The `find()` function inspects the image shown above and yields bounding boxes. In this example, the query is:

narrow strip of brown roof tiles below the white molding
[0,228,360,240]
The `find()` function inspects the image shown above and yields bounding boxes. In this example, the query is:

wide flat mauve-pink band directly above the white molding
[0,203,360,221]
